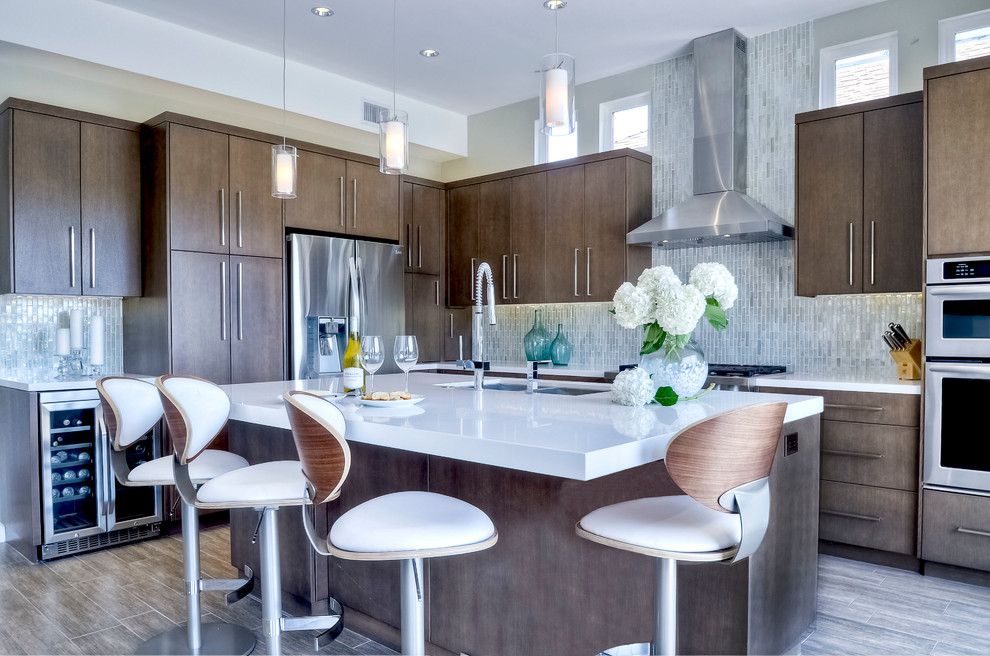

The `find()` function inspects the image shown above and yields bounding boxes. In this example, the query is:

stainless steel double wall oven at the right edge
[924,256,990,494]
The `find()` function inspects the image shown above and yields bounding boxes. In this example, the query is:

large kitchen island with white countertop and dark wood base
[225,373,822,656]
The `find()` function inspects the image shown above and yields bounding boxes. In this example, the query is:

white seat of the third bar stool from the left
[327,491,496,560]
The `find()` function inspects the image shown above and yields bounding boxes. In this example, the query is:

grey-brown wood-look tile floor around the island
[0,528,990,656]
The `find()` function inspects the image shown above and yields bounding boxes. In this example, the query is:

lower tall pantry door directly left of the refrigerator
[230,256,285,383]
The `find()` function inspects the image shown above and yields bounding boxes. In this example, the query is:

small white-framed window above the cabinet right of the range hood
[820,32,897,107]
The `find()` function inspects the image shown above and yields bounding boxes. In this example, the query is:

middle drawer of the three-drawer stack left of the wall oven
[821,420,919,492]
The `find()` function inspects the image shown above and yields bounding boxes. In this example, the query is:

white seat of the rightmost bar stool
[579,495,742,560]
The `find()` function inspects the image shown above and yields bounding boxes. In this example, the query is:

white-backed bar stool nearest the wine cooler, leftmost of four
[96,376,256,654]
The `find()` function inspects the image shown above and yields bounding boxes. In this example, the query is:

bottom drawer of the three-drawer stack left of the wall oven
[818,481,918,555]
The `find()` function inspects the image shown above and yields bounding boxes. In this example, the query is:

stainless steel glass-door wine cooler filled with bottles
[38,390,162,559]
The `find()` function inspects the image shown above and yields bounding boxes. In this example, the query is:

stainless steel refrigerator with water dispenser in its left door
[287,234,406,379]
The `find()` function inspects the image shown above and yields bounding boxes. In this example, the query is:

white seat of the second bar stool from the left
[198,453,311,508]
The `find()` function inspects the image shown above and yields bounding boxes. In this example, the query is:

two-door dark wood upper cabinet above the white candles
[0,100,141,296]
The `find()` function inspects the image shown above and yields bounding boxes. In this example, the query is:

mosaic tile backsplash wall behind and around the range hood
[486,23,921,374]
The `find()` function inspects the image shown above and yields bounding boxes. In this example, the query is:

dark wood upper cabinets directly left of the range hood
[447,150,652,307]
